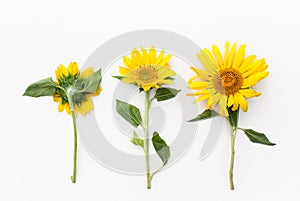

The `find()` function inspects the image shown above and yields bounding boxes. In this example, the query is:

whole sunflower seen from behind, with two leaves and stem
[23,62,101,183]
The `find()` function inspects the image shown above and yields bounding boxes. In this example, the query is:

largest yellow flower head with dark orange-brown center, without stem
[188,42,269,116]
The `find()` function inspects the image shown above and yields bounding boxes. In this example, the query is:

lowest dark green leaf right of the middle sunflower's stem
[152,131,171,165]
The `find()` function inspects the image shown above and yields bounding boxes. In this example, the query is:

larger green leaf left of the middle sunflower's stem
[117,100,142,127]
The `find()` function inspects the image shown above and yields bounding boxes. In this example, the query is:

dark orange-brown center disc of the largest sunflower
[213,68,243,96]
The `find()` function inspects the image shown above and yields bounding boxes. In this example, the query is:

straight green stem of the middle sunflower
[144,91,151,189]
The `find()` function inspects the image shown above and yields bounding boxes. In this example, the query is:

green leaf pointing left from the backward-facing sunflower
[23,77,56,97]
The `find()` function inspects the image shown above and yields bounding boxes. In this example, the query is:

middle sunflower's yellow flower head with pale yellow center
[119,47,175,91]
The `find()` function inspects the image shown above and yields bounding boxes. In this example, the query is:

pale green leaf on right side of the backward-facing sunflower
[81,69,102,93]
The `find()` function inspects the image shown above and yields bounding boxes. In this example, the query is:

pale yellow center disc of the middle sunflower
[136,64,158,83]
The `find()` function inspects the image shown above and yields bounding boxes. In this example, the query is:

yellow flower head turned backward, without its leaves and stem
[53,62,102,115]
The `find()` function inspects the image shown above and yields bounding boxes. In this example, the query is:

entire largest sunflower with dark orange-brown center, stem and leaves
[187,42,275,190]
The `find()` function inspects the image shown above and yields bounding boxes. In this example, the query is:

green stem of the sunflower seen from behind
[68,93,77,183]
